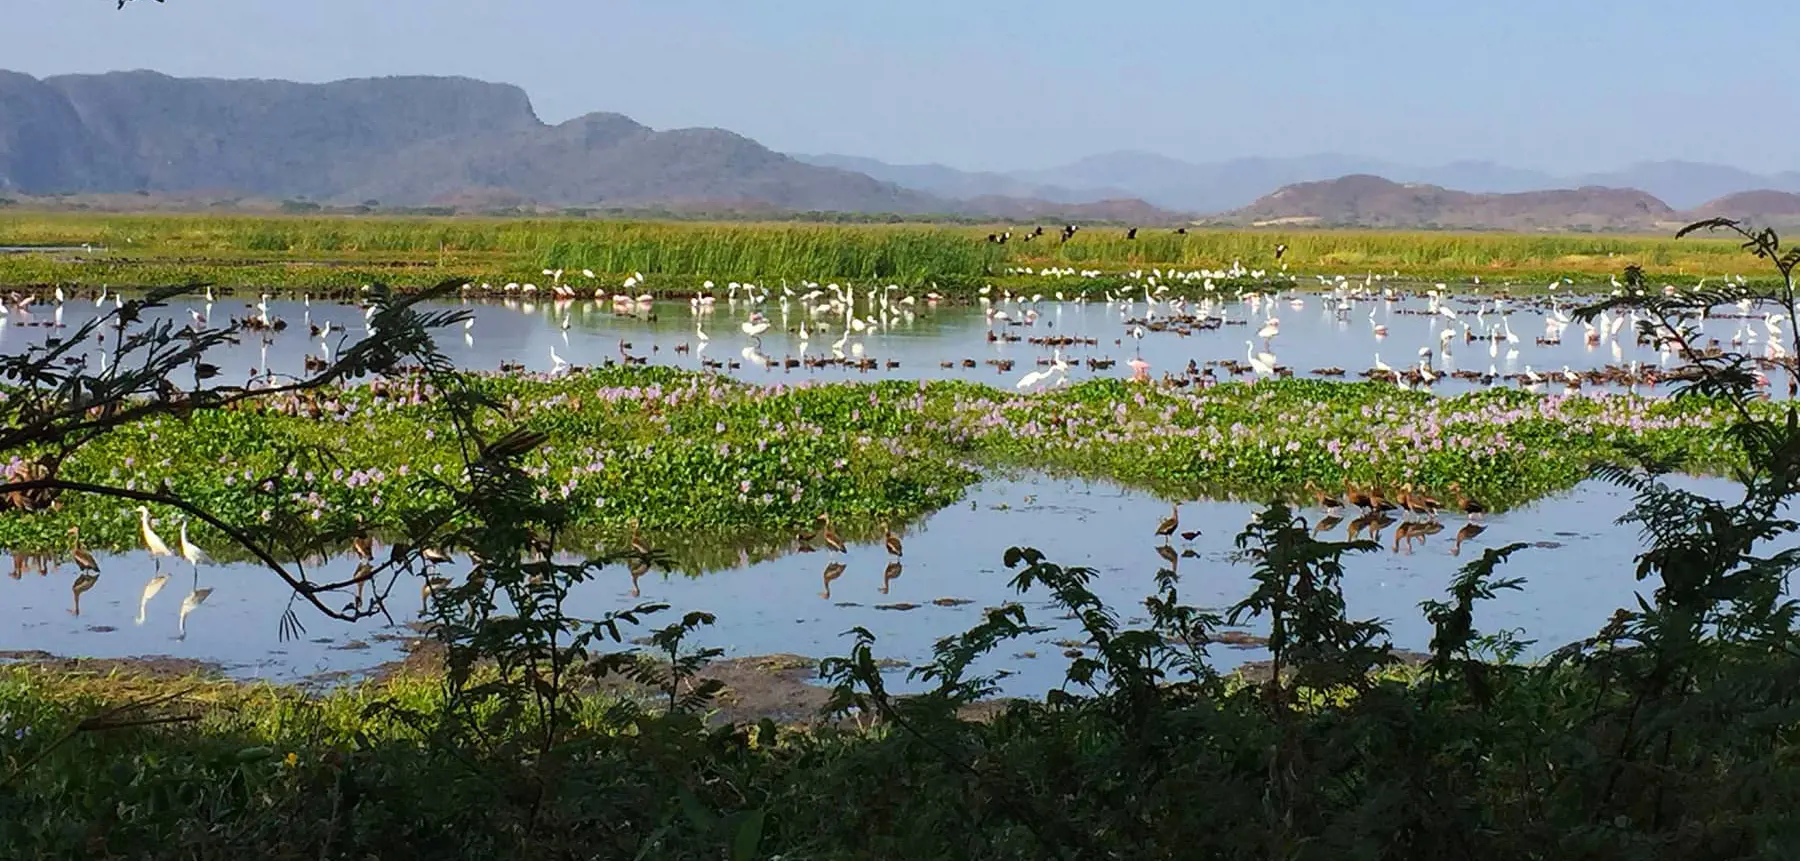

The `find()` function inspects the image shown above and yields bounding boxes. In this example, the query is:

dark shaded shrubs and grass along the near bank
[10,506,1800,859]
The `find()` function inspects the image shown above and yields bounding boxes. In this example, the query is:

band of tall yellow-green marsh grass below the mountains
[0,211,1771,292]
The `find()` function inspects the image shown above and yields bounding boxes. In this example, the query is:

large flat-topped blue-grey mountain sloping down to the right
[0,72,956,213]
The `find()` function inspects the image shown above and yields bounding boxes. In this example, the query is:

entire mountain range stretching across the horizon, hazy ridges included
[0,72,1800,229]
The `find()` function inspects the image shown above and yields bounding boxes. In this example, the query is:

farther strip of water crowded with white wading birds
[14,294,1768,394]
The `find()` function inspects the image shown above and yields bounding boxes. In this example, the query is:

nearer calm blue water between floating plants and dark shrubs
[0,476,1730,693]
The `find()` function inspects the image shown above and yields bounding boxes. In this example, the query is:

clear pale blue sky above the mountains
[14,0,1800,173]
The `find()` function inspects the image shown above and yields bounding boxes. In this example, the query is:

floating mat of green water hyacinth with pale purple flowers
[0,367,1739,551]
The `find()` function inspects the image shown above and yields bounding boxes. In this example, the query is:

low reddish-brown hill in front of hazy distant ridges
[1226,175,1679,231]
